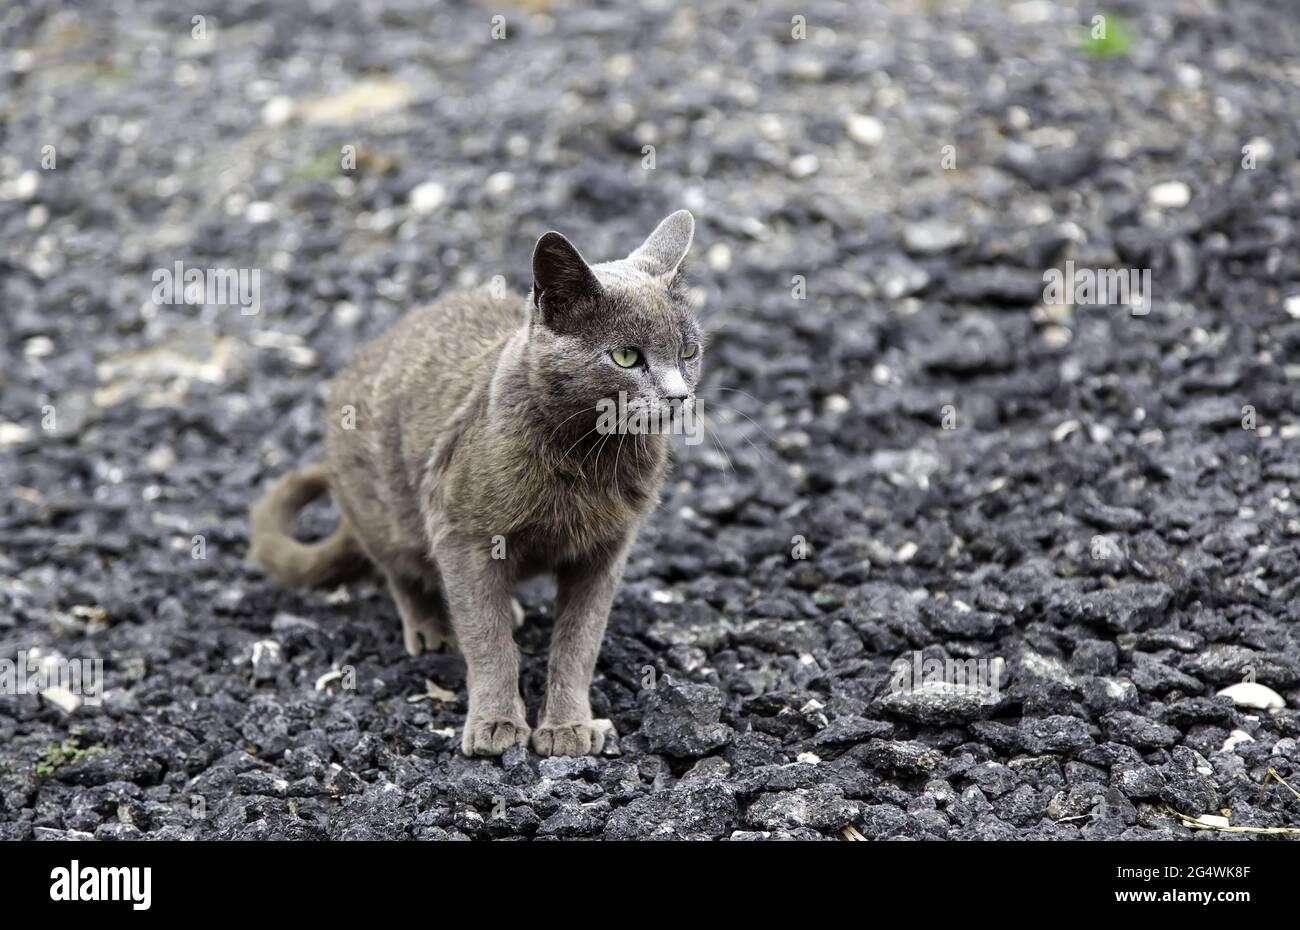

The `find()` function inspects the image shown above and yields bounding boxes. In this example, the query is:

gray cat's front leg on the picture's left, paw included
[436,538,529,756]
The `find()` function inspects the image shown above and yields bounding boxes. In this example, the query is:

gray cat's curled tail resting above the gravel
[250,464,368,588]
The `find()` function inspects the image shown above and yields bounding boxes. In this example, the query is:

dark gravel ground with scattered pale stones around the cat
[0,0,1300,839]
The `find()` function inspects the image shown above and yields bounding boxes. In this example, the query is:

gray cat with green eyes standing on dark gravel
[251,211,703,756]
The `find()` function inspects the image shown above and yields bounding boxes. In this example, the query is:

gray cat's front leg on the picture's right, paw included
[533,546,627,756]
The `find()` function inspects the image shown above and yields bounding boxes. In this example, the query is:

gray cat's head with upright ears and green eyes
[528,209,703,431]
